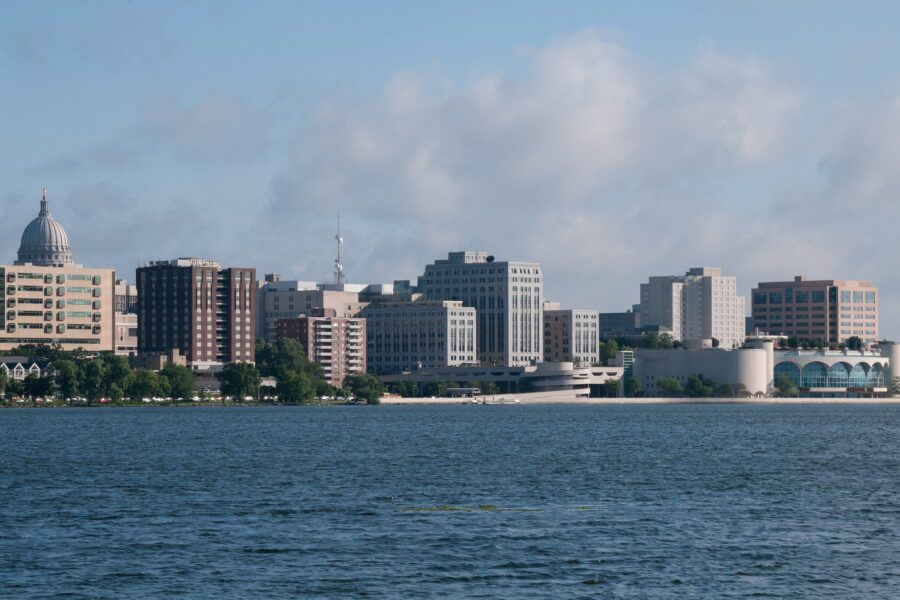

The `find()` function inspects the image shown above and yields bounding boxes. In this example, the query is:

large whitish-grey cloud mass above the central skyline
[266,31,803,310]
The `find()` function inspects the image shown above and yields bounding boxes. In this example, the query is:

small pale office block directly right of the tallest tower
[544,303,600,366]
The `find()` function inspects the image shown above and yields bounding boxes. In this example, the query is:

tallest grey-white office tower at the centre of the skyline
[417,252,544,366]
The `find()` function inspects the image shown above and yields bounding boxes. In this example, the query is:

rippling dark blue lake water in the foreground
[0,405,900,599]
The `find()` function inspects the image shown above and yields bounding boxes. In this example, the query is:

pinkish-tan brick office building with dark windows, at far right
[751,275,878,343]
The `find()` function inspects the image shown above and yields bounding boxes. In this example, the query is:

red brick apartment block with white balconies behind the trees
[277,308,366,388]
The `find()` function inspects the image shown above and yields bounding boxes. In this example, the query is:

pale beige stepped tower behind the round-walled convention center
[640,267,745,349]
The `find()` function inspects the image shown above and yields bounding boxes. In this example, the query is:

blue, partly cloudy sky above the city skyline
[0,0,900,339]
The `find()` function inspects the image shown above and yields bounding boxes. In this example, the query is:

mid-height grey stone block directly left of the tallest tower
[362,294,477,375]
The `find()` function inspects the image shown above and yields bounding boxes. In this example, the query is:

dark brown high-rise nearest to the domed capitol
[137,258,256,370]
